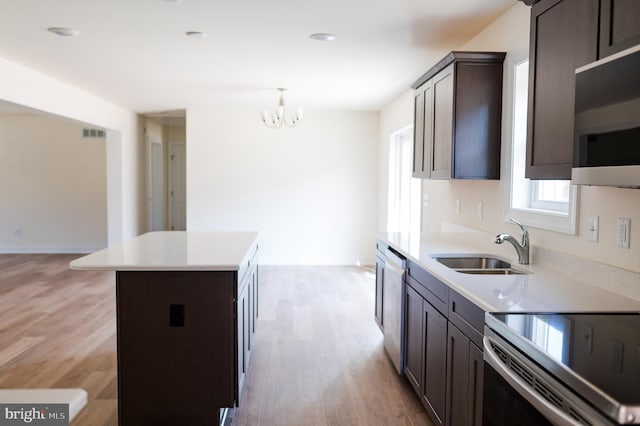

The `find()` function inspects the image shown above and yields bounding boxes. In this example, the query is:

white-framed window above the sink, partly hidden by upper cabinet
[505,55,577,234]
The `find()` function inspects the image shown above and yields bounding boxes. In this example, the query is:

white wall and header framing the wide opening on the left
[0,58,146,244]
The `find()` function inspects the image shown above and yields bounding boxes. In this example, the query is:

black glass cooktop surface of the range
[490,313,640,405]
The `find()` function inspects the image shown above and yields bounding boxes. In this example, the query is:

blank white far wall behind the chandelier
[187,108,379,264]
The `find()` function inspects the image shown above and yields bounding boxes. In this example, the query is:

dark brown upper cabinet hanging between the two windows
[411,52,505,179]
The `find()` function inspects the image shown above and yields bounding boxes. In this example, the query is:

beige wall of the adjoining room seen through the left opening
[0,115,107,253]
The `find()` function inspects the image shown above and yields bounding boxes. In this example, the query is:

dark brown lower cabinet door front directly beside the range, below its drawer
[447,323,484,426]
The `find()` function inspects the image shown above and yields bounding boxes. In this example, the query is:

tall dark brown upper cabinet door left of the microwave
[525,0,599,179]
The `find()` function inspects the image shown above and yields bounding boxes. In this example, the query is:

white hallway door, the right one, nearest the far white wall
[169,142,187,231]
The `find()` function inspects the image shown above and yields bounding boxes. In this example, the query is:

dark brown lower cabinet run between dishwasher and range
[404,261,484,426]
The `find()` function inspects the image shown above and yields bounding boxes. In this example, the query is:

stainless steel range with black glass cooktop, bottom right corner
[483,313,640,426]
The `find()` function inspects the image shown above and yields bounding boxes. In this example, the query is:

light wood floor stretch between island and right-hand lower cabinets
[233,266,432,425]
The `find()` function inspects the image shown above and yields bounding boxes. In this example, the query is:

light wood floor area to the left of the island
[0,254,117,425]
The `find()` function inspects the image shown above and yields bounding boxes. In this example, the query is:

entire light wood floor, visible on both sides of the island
[0,255,431,426]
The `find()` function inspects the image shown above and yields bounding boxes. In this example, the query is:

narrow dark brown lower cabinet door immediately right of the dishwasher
[404,285,426,394]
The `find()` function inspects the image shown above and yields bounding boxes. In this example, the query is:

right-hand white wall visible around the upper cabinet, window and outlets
[379,2,640,272]
